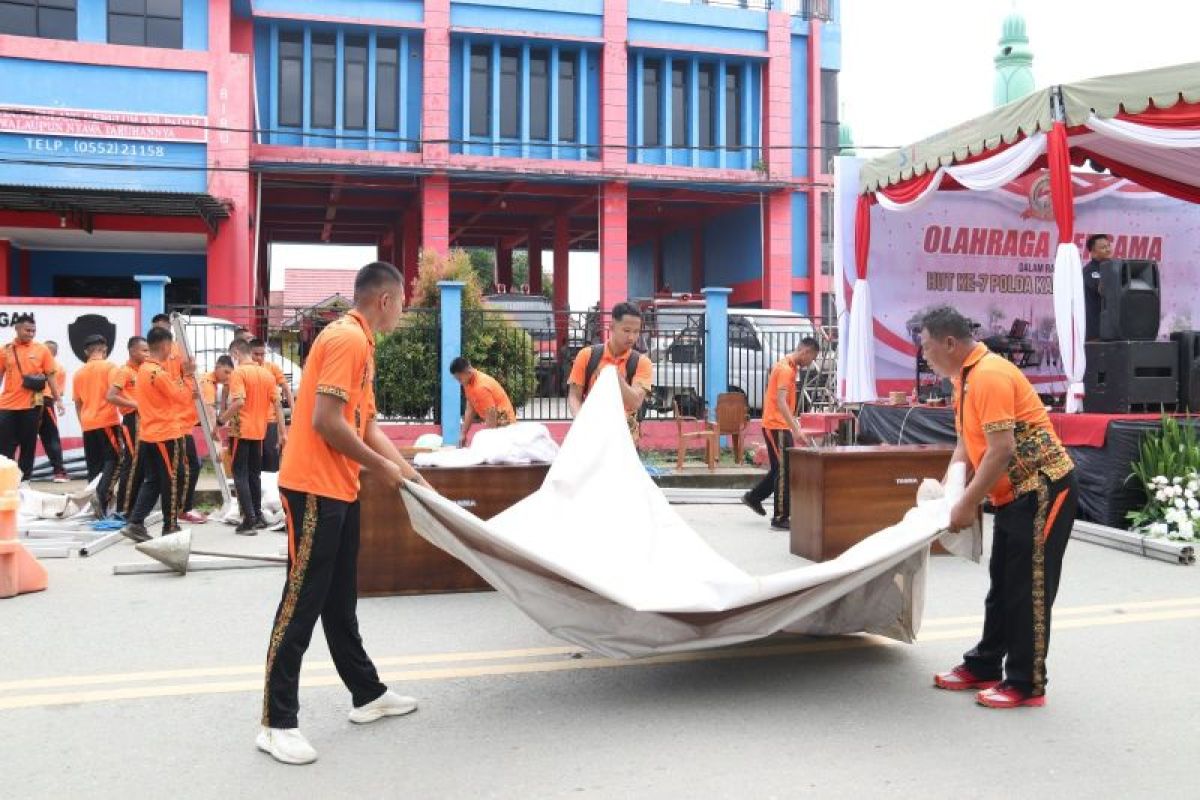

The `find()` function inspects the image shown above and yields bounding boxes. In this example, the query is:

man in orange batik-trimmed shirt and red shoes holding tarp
[920,306,1078,709]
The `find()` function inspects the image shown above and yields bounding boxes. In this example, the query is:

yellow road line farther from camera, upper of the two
[0,596,1200,695]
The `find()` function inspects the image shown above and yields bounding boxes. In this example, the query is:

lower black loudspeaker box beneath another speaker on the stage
[1084,342,1180,414]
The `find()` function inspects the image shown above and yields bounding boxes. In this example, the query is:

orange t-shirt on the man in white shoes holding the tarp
[280,311,376,503]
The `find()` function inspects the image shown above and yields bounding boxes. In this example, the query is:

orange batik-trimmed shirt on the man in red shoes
[954,343,1075,506]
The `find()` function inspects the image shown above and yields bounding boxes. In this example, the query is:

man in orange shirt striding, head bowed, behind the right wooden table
[742,336,821,530]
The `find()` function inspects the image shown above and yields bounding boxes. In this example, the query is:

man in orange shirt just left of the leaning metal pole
[121,327,196,542]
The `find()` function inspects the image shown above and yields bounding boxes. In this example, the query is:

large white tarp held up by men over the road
[402,369,969,657]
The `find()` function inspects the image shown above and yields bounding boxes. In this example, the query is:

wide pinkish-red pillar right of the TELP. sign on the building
[208,0,259,311]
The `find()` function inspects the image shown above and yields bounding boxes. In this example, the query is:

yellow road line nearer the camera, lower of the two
[0,608,1200,710]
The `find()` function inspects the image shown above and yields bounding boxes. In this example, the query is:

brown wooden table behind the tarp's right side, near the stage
[787,445,954,561]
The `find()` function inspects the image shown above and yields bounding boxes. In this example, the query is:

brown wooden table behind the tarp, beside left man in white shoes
[359,464,550,596]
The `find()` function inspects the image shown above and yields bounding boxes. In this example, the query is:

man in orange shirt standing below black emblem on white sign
[72,335,122,519]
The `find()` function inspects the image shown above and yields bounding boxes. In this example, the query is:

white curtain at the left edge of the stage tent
[833,156,878,403]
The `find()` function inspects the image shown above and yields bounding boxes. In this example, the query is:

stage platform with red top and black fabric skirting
[858,403,1188,528]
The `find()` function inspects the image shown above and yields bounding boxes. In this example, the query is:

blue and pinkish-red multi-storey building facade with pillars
[0,0,840,313]
